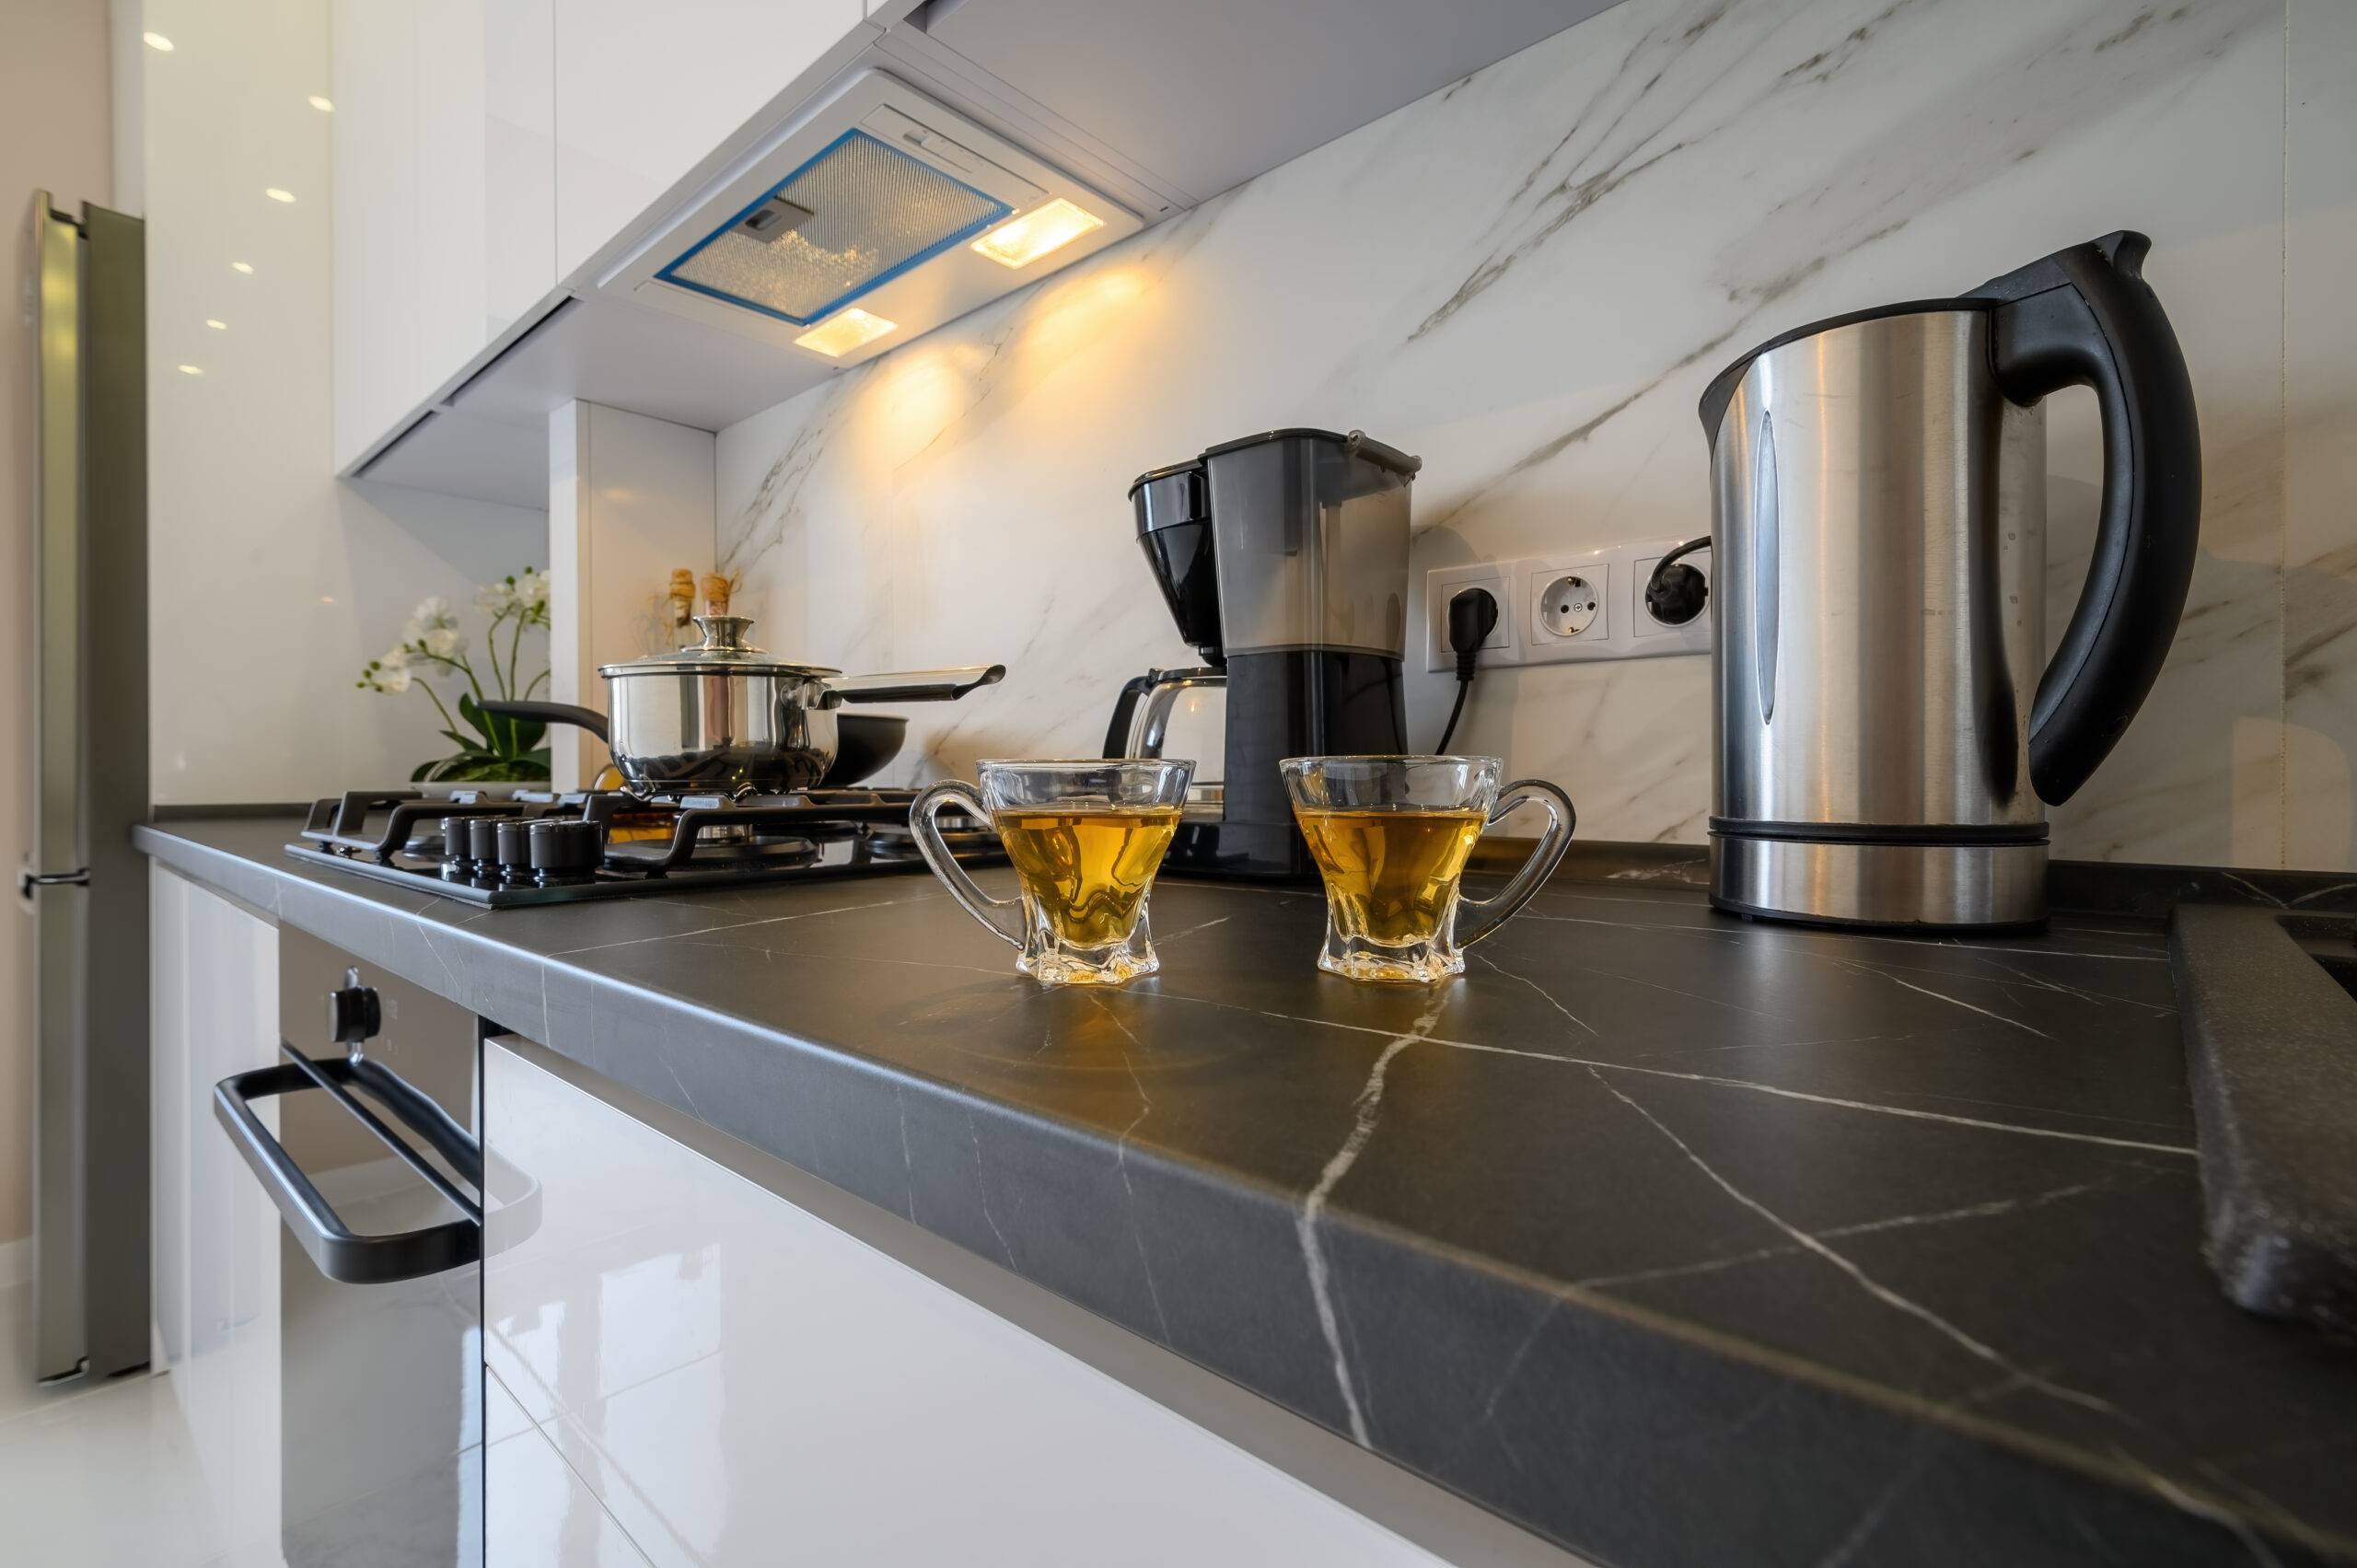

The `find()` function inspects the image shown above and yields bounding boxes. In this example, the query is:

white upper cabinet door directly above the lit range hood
[556,0,863,276]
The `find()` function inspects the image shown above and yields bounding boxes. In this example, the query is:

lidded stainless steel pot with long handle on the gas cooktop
[483,615,1006,795]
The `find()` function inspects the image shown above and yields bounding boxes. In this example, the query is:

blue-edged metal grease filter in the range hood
[657,130,1014,325]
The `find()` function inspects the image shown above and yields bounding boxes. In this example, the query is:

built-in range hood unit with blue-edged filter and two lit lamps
[598,71,1141,366]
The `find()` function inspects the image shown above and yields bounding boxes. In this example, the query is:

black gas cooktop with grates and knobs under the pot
[287,785,999,908]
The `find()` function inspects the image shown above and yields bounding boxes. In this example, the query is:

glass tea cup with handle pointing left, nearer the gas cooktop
[910,757,1195,985]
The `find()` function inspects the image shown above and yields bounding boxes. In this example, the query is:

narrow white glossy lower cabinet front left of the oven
[148,865,278,1550]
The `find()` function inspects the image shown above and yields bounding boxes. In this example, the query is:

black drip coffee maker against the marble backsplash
[1106,429,1422,879]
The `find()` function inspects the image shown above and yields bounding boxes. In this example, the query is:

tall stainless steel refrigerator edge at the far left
[17,191,151,1379]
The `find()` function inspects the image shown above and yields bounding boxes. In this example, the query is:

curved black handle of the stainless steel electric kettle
[1970,228,2201,807]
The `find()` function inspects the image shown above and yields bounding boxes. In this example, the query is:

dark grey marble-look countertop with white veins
[139,819,2357,1565]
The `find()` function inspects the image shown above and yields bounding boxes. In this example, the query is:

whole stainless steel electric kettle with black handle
[1701,231,2201,926]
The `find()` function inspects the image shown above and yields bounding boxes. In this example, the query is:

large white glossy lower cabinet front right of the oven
[483,1044,1435,1568]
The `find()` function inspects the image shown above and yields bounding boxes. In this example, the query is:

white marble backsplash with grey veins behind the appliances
[719,0,2357,867]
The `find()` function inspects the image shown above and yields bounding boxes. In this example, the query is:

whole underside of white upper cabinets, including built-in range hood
[340,0,1612,507]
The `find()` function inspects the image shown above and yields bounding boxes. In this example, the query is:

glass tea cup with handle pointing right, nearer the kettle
[1278,757,1577,983]
